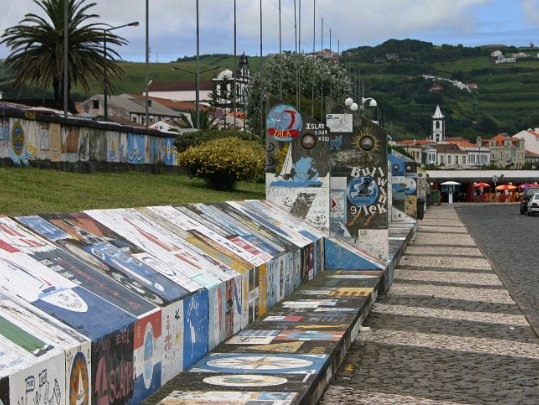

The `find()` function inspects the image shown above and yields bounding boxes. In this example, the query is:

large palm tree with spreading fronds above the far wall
[0,0,127,110]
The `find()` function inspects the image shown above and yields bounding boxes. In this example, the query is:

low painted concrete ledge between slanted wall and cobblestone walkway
[144,270,383,405]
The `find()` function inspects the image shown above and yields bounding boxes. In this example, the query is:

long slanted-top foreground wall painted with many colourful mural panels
[0,200,325,405]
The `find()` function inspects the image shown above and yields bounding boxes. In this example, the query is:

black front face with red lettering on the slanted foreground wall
[92,325,135,405]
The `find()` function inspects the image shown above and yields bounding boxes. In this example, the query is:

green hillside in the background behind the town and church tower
[0,40,539,139]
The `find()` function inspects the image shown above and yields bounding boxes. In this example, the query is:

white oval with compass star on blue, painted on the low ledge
[207,356,313,370]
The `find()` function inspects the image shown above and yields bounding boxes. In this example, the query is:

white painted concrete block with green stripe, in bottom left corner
[0,293,91,404]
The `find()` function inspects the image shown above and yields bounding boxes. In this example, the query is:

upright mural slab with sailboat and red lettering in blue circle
[266,103,329,229]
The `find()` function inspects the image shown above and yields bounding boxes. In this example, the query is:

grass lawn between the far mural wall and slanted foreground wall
[0,168,265,215]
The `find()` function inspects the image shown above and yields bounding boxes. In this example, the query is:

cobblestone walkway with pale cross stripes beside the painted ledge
[320,206,539,405]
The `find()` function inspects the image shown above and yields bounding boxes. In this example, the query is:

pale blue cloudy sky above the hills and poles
[0,0,539,62]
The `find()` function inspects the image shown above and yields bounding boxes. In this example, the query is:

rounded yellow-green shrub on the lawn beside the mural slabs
[178,137,266,190]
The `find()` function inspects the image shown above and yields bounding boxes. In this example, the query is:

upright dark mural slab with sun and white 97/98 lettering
[327,108,389,260]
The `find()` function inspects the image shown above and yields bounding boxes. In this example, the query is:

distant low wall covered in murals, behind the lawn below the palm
[0,111,176,170]
